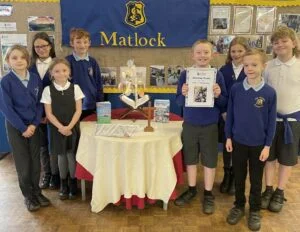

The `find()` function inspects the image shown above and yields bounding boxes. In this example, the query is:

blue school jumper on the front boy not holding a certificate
[225,79,276,146]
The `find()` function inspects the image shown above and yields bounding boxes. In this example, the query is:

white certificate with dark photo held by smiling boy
[185,68,217,107]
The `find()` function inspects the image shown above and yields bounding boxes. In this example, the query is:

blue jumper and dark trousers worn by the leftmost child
[0,71,42,198]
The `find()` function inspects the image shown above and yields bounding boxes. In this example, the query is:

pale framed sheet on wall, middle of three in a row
[233,6,253,34]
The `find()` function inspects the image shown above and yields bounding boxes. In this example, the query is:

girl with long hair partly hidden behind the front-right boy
[219,37,248,195]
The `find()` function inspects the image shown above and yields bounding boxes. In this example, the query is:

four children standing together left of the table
[0,28,103,211]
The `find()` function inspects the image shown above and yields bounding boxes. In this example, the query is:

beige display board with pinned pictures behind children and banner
[0,1,300,90]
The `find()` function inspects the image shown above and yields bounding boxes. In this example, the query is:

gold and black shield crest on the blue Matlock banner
[125,1,146,28]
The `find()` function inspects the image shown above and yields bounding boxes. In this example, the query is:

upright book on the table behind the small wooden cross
[154,99,170,123]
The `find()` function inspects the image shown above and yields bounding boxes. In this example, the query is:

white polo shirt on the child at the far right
[264,56,300,114]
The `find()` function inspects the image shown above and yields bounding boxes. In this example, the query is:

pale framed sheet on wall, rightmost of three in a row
[256,7,276,34]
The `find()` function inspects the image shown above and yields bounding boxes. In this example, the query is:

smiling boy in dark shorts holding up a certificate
[175,40,227,214]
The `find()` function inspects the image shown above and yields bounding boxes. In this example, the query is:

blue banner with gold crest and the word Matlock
[60,0,209,48]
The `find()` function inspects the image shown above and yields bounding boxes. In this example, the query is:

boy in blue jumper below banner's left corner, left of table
[66,28,103,119]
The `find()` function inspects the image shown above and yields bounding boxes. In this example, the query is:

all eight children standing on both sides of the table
[0,22,300,230]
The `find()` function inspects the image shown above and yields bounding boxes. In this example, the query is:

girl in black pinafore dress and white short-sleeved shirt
[41,58,84,200]
